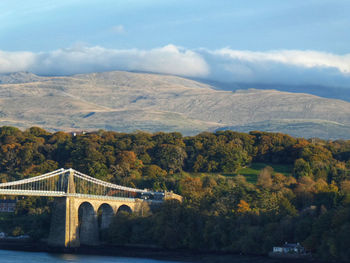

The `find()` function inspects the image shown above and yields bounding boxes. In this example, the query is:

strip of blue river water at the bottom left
[0,250,189,263]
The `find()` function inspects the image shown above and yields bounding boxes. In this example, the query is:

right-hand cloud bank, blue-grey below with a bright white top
[199,48,350,86]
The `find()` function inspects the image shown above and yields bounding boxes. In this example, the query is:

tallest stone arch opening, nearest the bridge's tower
[78,202,98,245]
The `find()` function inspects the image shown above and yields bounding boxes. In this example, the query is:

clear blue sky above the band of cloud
[0,0,350,54]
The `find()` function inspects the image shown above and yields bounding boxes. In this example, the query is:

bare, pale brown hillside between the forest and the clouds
[0,71,350,139]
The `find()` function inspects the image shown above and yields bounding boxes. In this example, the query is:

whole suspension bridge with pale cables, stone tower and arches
[0,168,181,248]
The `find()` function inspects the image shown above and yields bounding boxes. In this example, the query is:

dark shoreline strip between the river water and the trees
[0,241,318,263]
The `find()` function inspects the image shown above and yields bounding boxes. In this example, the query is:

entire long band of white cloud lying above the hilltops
[0,45,350,87]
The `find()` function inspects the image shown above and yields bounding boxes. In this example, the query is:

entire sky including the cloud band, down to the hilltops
[0,0,350,86]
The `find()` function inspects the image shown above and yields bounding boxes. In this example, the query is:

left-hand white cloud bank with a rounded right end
[0,45,209,77]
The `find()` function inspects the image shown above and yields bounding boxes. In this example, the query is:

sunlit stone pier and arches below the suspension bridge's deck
[48,196,148,248]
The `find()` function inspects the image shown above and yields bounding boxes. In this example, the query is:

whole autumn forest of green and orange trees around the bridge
[0,126,350,262]
